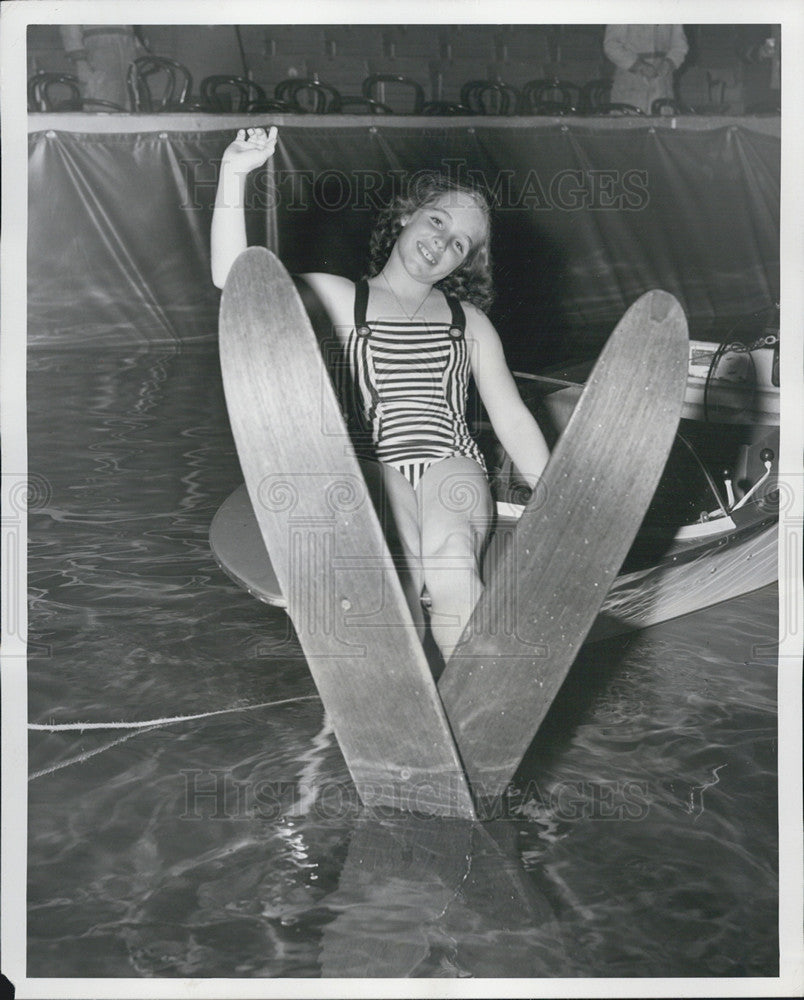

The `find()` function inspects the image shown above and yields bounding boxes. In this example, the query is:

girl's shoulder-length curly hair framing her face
[366,171,494,312]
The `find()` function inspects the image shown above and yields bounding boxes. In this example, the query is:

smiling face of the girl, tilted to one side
[395,191,488,285]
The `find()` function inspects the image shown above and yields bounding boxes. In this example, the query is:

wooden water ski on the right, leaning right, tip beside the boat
[439,291,688,804]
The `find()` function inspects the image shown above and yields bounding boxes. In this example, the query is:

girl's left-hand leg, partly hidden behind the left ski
[360,458,425,639]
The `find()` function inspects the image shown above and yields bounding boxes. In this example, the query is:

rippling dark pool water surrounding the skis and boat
[28,349,778,978]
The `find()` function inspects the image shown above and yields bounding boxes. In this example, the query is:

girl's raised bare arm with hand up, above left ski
[210,126,276,288]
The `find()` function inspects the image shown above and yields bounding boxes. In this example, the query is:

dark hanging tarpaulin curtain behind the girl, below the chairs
[29,119,780,368]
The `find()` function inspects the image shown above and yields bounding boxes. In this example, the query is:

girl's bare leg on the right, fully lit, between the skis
[417,456,493,661]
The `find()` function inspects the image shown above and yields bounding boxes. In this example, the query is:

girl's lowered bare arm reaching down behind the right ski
[465,306,550,487]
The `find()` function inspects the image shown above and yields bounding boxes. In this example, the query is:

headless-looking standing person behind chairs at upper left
[59,24,145,110]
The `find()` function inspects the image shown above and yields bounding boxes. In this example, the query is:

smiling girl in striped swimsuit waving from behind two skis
[212,128,548,660]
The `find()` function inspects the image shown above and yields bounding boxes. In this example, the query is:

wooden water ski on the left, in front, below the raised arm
[220,247,474,819]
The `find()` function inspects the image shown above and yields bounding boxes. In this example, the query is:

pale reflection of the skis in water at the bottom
[321,815,563,977]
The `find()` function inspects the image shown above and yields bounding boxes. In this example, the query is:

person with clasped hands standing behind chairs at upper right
[603,24,689,114]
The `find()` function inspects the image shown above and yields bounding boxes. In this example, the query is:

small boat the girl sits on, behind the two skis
[210,341,779,642]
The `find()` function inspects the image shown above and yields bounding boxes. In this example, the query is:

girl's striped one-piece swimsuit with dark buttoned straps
[341,280,485,489]
